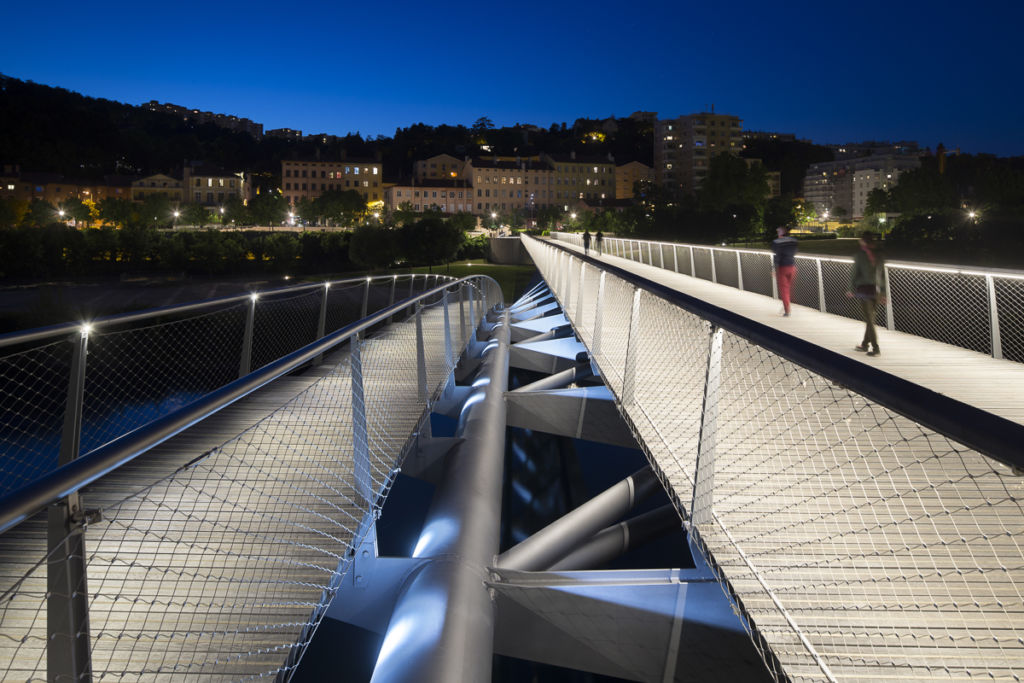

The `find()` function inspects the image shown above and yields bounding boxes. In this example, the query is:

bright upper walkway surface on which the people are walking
[554,242,1024,424]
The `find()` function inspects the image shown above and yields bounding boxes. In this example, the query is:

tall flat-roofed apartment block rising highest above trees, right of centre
[654,112,743,194]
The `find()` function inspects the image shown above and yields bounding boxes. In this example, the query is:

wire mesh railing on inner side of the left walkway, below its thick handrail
[0,279,501,680]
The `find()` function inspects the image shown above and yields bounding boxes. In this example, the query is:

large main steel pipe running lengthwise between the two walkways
[371,312,510,683]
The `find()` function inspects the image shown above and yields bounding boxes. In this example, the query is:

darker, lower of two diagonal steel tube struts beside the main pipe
[548,503,682,571]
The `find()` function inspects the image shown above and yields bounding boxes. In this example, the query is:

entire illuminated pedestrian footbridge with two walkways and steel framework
[0,236,1024,682]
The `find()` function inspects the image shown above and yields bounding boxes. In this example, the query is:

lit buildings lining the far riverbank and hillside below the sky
[6,107,920,223]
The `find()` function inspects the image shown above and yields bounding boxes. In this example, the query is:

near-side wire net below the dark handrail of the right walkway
[527,241,1024,681]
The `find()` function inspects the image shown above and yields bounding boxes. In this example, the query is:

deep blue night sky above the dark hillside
[0,0,1024,155]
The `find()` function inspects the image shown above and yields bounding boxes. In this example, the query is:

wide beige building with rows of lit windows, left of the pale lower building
[281,159,384,206]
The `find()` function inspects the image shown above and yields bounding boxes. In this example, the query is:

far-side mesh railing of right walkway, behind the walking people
[553,232,1024,362]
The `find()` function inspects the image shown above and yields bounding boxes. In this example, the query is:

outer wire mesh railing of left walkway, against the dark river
[0,275,452,495]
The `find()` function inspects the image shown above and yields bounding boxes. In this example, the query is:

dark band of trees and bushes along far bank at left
[0,215,486,280]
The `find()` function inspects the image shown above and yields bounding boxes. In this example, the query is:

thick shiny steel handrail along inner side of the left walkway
[0,275,500,533]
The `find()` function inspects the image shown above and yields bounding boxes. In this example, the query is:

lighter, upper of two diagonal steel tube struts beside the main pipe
[495,467,660,571]
